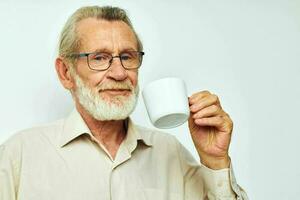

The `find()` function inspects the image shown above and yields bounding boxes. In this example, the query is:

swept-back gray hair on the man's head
[58,6,143,62]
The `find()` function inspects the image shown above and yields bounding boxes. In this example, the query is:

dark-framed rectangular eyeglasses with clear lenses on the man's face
[70,51,145,71]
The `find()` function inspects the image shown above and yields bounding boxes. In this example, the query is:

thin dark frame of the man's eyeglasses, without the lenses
[70,51,145,71]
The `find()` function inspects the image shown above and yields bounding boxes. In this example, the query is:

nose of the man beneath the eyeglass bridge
[107,56,128,81]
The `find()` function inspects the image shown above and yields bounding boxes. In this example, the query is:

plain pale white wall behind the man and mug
[0,0,300,200]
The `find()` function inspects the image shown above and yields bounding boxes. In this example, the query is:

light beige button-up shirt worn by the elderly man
[0,110,247,200]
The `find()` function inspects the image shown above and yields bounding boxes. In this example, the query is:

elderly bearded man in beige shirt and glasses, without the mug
[0,6,247,200]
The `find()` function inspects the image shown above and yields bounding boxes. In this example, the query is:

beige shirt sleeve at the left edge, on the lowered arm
[0,145,16,200]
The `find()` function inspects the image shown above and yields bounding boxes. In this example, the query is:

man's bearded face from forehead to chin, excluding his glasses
[71,18,139,120]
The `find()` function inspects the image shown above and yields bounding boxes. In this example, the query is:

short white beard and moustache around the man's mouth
[70,67,139,121]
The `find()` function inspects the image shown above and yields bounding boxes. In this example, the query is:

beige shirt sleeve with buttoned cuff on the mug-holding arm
[173,138,248,200]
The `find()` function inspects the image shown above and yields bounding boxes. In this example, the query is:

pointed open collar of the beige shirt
[60,108,153,147]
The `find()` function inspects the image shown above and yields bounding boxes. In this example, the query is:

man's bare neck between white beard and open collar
[76,104,126,149]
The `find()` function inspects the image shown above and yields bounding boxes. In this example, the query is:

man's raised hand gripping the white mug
[189,91,233,169]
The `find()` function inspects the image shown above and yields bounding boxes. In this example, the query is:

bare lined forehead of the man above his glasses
[77,18,137,51]
